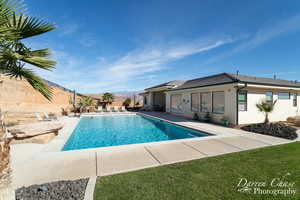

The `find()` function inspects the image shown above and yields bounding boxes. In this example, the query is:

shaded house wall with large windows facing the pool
[166,84,237,124]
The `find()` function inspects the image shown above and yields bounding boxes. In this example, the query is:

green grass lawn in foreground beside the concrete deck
[94,142,300,200]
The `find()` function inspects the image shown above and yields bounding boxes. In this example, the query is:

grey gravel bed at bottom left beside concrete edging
[16,179,89,200]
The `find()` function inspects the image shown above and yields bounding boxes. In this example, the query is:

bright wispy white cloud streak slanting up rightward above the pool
[86,38,234,89]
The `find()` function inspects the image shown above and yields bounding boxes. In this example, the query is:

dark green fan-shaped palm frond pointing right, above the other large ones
[7,14,56,39]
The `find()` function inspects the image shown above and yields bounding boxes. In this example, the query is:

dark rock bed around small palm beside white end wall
[241,123,298,140]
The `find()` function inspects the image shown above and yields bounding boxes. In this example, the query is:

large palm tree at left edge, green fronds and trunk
[0,0,56,195]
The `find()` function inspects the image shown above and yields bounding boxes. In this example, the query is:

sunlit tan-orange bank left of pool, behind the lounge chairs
[0,75,78,122]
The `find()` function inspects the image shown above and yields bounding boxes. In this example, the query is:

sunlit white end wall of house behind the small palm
[238,88,300,124]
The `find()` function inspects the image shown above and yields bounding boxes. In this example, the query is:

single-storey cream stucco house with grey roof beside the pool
[142,73,300,125]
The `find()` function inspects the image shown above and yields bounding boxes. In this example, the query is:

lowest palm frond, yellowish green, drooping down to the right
[0,66,53,101]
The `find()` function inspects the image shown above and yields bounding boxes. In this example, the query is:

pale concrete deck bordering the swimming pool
[12,112,299,188]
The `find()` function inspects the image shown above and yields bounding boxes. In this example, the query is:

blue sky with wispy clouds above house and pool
[25,0,300,93]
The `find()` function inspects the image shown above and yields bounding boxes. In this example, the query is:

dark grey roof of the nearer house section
[171,73,300,90]
